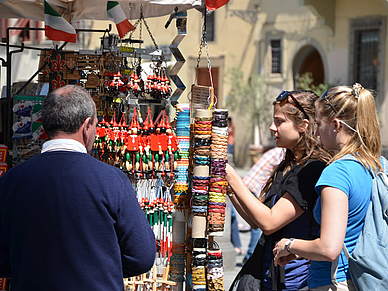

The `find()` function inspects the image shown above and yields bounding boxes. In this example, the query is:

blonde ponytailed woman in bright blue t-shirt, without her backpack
[273,83,382,290]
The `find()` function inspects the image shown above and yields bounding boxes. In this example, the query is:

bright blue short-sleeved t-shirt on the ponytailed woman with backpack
[308,160,372,288]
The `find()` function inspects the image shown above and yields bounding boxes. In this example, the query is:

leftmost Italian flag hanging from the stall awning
[44,1,77,43]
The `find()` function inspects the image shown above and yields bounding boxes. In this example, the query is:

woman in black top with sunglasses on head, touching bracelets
[226,90,329,290]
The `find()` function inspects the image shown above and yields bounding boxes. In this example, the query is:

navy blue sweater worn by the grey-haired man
[0,152,155,291]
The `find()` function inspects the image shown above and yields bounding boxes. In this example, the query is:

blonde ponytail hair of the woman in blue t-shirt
[317,84,382,171]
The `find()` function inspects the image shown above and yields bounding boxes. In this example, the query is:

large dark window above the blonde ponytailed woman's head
[350,19,383,91]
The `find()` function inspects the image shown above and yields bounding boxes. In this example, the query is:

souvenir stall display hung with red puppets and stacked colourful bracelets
[1,0,228,290]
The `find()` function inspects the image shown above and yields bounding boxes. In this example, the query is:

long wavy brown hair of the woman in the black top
[259,90,331,202]
